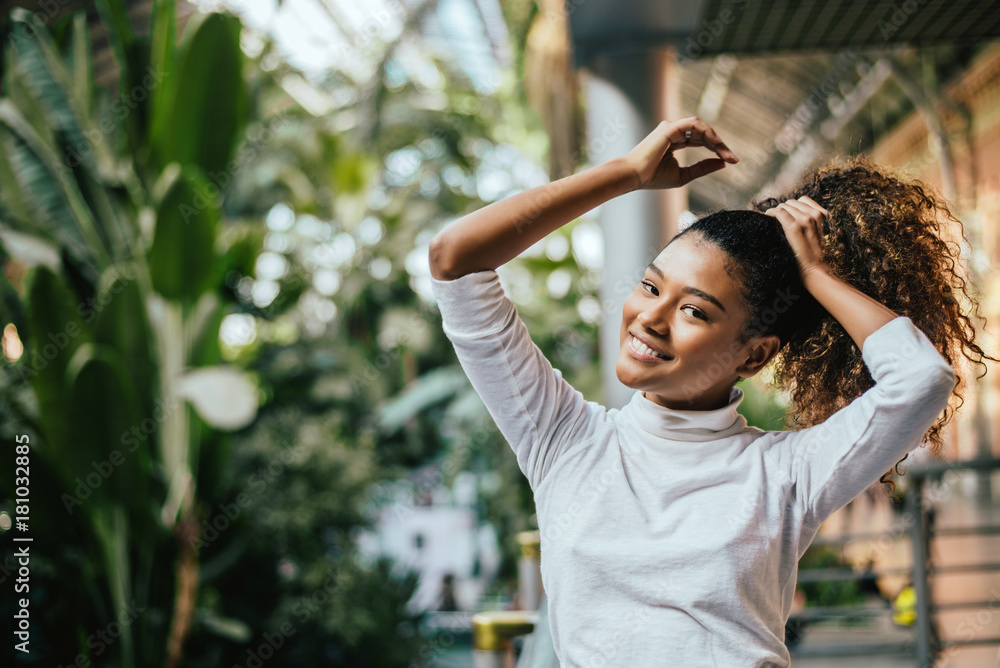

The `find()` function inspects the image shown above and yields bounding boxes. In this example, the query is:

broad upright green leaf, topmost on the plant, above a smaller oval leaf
[152,14,249,182]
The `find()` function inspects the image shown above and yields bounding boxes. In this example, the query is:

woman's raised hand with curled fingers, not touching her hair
[625,116,740,190]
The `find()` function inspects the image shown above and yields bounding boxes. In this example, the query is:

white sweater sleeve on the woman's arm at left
[431,270,606,489]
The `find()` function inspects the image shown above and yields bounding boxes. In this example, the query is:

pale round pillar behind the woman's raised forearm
[583,49,687,408]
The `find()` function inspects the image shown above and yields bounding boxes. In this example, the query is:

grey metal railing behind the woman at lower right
[790,459,1000,666]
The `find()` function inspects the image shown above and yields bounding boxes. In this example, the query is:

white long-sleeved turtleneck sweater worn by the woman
[431,271,955,668]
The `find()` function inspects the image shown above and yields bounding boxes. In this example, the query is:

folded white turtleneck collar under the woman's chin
[622,387,747,441]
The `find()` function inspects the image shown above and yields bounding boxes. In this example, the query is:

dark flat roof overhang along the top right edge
[566,0,1000,63]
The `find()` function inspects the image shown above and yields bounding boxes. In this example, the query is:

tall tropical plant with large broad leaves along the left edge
[0,0,258,668]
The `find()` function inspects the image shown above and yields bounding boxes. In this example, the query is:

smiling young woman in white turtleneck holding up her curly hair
[430,118,984,668]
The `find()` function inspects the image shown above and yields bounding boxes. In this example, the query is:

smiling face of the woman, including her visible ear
[615,233,778,410]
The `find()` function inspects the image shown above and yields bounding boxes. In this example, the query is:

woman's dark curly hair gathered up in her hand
[674,157,1000,492]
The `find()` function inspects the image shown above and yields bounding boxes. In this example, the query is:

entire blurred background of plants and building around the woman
[0,0,1000,668]
